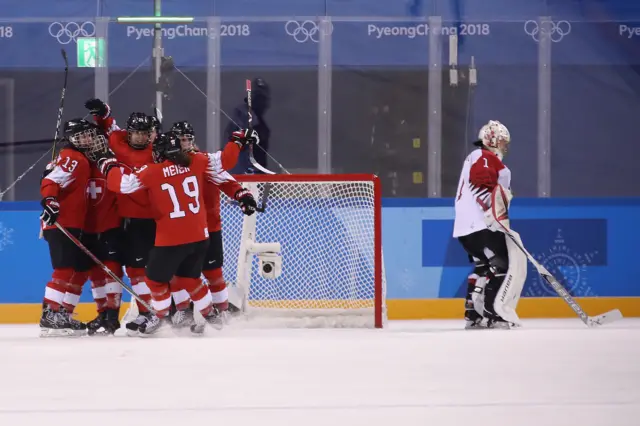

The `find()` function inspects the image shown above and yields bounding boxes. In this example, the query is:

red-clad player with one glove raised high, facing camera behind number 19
[85,99,157,331]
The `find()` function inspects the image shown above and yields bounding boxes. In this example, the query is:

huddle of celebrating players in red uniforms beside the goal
[40,99,259,336]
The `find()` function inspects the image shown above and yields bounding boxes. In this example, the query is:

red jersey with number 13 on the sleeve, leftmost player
[40,148,91,229]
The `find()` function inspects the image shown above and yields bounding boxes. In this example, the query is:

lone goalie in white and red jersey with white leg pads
[453,120,527,328]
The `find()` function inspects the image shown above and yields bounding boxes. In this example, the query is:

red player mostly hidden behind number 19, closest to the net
[171,121,259,322]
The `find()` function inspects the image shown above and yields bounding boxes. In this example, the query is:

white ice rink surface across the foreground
[0,319,640,426]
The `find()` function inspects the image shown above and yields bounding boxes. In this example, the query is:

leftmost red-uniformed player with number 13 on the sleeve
[40,118,105,336]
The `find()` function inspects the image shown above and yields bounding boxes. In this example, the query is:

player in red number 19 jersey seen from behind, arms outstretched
[93,132,256,334]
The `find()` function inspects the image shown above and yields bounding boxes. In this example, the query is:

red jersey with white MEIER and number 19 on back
[107,152,237,246]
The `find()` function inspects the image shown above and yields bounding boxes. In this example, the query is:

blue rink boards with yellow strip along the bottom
[0,199,640,322]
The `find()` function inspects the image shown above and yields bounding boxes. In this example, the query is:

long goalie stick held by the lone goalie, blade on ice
[491,185,622,328]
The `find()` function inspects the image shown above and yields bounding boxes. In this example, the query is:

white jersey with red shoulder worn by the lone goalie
[453,149,511,238]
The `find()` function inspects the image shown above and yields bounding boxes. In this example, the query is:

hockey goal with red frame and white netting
[220,174,386,328]
